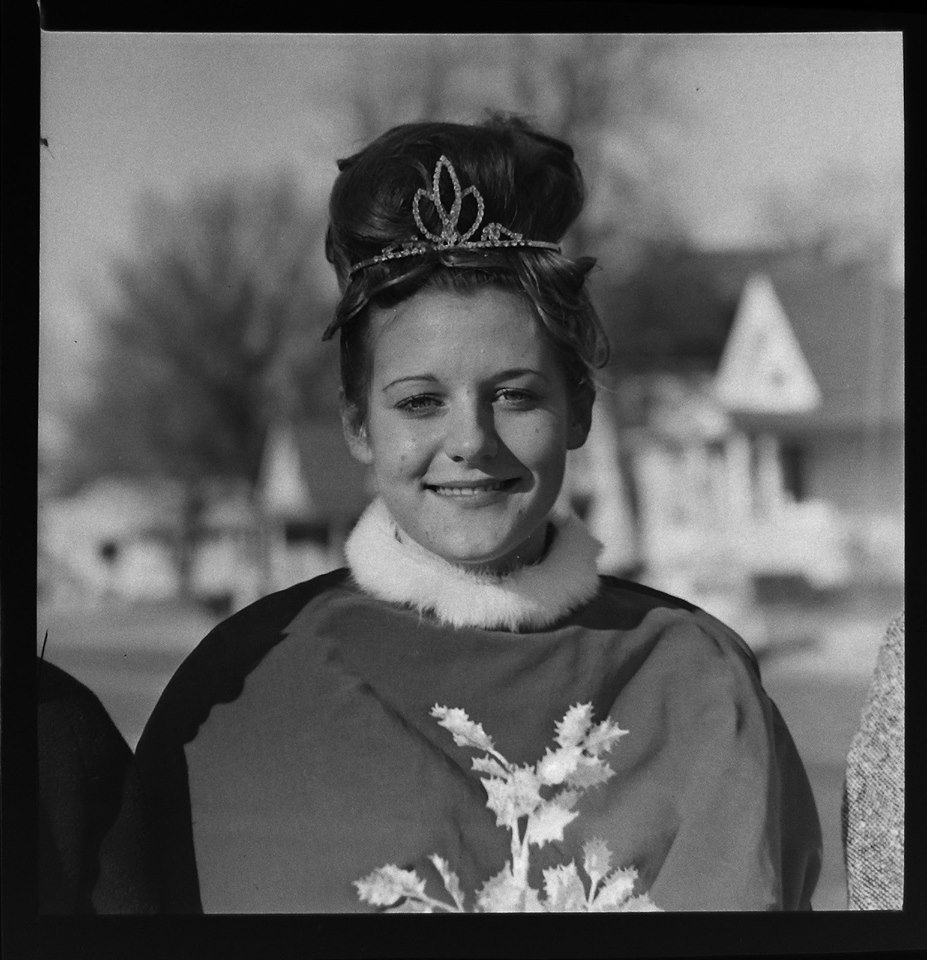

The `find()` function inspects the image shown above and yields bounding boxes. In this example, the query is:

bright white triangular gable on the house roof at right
[715,274,821,414]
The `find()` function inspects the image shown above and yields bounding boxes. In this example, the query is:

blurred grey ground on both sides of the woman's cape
[38,591,901,910]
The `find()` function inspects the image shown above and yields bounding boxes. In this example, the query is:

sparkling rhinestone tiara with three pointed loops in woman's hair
[348,154,560,277]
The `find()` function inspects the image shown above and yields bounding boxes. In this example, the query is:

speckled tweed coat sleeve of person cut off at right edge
[842,613,904,910]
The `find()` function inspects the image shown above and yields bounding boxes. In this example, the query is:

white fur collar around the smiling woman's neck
[345,498,602,630]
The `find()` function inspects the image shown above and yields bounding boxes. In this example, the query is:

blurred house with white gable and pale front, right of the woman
[571,238,904,597]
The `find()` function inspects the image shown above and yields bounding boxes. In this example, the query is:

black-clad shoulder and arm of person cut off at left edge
[37,661,151,913]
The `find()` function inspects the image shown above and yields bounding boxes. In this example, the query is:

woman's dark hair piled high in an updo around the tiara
[325,115,608,419]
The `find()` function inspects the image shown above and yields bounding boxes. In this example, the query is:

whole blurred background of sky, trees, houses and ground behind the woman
[36,33,904,910]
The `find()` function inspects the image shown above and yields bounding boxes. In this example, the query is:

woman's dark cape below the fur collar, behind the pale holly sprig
[112,571,821,913]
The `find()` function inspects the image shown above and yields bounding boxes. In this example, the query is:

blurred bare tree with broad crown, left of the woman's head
[71,172,331,592]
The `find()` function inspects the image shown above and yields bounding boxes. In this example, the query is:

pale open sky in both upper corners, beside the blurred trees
[40,33,904,444]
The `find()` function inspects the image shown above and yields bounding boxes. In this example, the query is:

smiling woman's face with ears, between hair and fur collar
[345,287,588,570]
